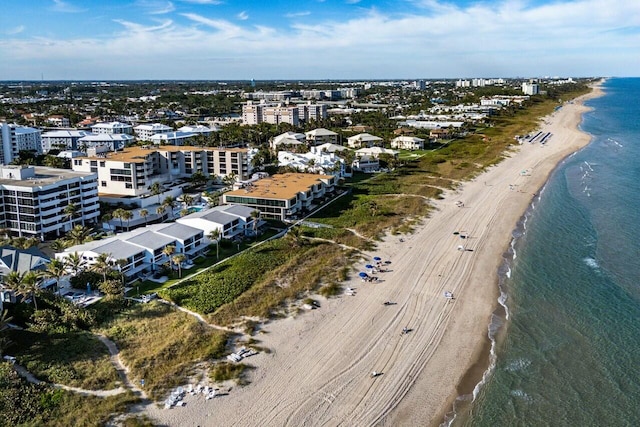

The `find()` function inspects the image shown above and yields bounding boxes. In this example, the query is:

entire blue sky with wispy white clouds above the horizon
[0,0,640,80]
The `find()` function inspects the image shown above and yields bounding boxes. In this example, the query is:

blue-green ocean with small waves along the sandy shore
[452,78,640,426]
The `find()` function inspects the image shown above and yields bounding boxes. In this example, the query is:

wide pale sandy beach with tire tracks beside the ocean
[147,87,601,426]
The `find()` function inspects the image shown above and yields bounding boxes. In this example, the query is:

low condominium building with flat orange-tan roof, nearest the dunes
[222,173,337,221]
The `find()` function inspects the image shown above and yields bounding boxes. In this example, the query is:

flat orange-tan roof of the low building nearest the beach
[225,173,333,200]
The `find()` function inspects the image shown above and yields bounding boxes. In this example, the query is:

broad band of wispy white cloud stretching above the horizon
[0,0,640,80]
